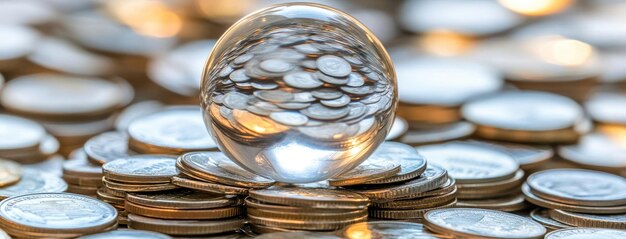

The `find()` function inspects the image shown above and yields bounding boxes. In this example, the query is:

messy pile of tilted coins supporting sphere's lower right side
[329,142,457,221]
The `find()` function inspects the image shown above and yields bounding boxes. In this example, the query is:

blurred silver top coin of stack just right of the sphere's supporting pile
[416,141,519,184]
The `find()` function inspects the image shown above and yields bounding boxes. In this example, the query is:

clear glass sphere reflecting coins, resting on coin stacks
[201,3,397,183]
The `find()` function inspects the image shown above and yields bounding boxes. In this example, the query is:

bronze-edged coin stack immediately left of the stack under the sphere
[125,189,245,236]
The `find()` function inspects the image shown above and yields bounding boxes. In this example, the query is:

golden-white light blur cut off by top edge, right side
[498,0,573,16]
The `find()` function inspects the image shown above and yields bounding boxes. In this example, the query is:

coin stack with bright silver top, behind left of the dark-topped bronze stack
[98,155,177,224]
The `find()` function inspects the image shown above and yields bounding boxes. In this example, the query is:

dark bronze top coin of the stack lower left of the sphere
[126,189,243,209]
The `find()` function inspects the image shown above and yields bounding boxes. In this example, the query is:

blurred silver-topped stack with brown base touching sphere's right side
[395,57,503,124]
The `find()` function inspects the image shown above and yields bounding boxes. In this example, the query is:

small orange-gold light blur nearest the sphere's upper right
[418,30,474,56]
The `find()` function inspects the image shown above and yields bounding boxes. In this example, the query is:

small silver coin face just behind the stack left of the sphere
[83,132,129,165]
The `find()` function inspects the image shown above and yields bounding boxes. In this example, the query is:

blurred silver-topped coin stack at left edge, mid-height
[0,74,134,155]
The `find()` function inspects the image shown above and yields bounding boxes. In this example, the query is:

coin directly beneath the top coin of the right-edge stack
[522,184,626,214]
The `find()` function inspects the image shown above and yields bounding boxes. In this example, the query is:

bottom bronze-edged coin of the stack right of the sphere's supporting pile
[456,194,528,212]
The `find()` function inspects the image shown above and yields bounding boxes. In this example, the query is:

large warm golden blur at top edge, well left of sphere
[106,0,183,37]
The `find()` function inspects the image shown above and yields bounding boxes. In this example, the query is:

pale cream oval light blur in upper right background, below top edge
[529,36,595,67]
